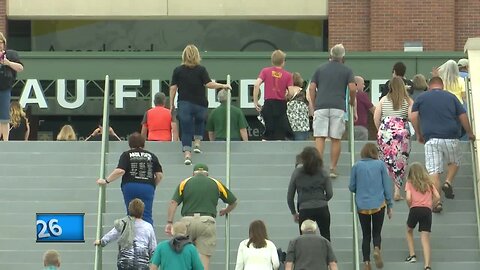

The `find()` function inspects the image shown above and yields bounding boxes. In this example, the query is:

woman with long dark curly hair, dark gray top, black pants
[287,146,333,241]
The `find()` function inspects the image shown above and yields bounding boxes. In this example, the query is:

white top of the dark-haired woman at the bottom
[235,239,280,270]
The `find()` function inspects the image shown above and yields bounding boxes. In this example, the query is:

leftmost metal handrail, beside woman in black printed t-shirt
[94,75,110,270]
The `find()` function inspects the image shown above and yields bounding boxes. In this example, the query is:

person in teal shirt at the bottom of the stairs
[150,222,204,270]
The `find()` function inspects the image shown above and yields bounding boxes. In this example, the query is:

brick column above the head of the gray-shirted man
[328,0,370,53]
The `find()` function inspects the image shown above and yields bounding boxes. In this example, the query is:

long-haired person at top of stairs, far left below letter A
[9,101,30,141]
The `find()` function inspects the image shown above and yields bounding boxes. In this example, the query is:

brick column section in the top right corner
[455,0,480,51]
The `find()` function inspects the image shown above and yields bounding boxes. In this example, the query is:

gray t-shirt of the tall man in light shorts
[312,61,355,111]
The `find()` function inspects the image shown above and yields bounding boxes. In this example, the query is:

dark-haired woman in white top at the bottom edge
[235,220,280,270]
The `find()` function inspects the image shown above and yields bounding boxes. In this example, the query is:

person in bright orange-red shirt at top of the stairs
[141,92,178,141]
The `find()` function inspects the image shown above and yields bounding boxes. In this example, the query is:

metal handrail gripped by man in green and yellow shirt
[225,75,232,270]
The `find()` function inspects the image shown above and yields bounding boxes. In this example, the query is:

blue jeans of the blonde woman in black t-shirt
[177,100,207,151]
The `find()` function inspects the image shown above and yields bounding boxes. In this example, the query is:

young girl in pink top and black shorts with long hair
[405,162,440,270]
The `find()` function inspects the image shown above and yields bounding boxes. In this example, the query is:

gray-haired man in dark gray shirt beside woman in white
[285,219,338,270]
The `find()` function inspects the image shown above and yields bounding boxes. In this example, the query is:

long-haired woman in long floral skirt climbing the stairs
[373,77,413,201]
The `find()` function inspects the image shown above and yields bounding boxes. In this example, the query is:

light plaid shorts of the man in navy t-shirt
[425,139,462,174]
